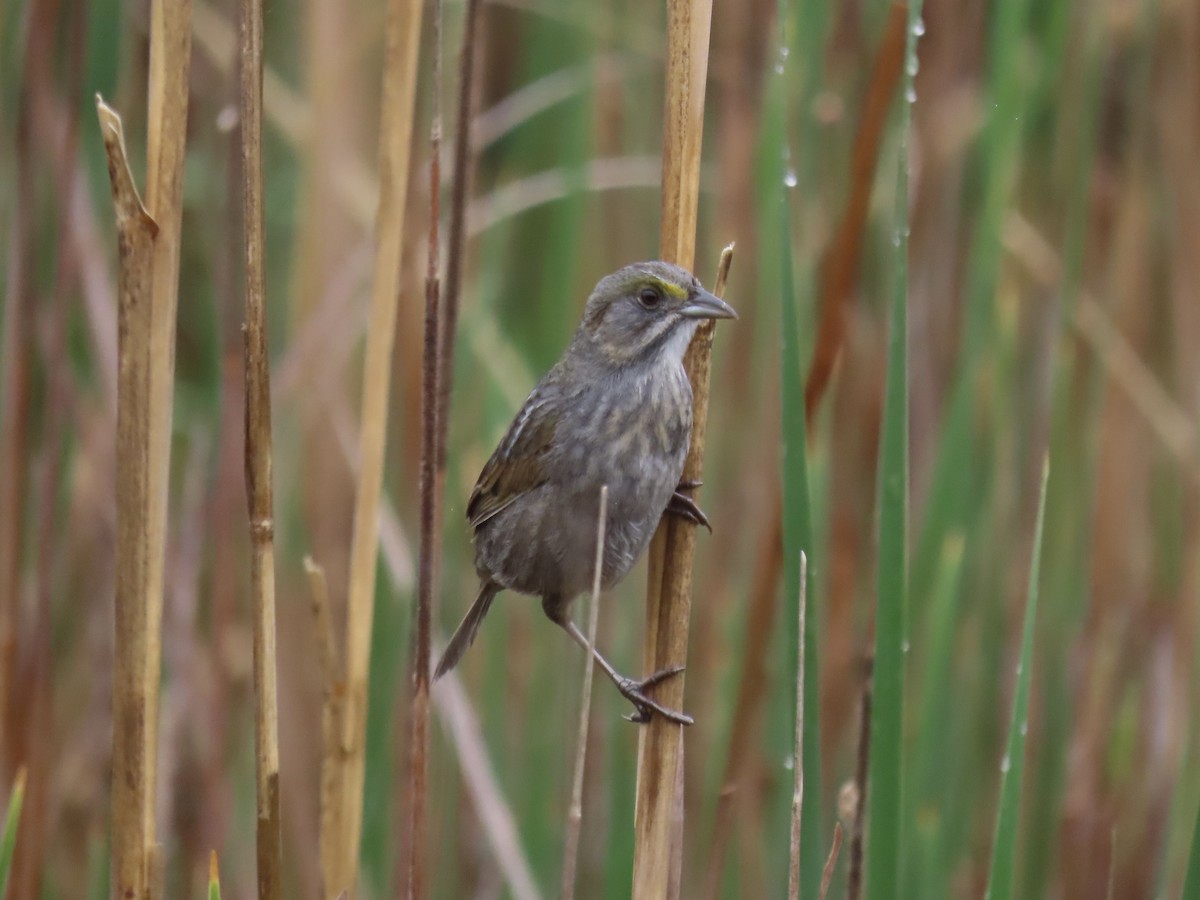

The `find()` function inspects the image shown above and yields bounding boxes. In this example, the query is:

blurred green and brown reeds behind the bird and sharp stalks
[0,0,1200,898]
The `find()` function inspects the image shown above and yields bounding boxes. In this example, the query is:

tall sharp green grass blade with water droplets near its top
[866,0,924,900]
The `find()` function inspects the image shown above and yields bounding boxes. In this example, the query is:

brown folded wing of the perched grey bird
[467,386,558,529]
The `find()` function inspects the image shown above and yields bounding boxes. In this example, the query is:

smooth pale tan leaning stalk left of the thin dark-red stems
[333,0,421,895]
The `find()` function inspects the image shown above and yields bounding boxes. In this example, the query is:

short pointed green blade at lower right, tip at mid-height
[985,460,1050,900]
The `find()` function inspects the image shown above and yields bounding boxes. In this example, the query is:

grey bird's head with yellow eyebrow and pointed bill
[576,260,738,365]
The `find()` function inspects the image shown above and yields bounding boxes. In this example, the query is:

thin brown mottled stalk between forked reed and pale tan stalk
[239,0,283,900]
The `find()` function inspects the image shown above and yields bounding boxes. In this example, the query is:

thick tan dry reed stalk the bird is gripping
[632,0,732,859]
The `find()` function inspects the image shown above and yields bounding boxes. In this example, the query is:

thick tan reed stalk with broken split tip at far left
[96,26,191,899]
